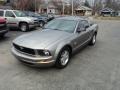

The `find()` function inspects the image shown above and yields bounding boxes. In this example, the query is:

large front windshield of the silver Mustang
[45,19,77,33]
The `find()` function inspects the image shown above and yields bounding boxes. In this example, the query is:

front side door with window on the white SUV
[5,11,17,27]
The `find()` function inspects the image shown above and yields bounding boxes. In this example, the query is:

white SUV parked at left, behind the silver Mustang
[0,9,38,31]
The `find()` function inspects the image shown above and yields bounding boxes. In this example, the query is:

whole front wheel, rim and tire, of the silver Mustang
[56,48,70,69]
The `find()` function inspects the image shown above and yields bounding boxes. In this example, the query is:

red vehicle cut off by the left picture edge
[0,17,8,37]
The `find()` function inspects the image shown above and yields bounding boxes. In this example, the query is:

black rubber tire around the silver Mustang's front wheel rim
[55,47,71,69]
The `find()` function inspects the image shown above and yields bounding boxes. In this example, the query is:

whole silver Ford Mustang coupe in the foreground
[12,16,98,68]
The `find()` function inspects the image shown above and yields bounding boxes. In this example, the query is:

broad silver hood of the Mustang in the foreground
[13,29,71,49]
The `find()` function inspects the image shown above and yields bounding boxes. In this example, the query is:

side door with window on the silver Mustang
[75,20,89,48]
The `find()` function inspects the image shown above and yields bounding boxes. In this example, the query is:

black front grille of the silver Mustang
[13,44,35,55]
